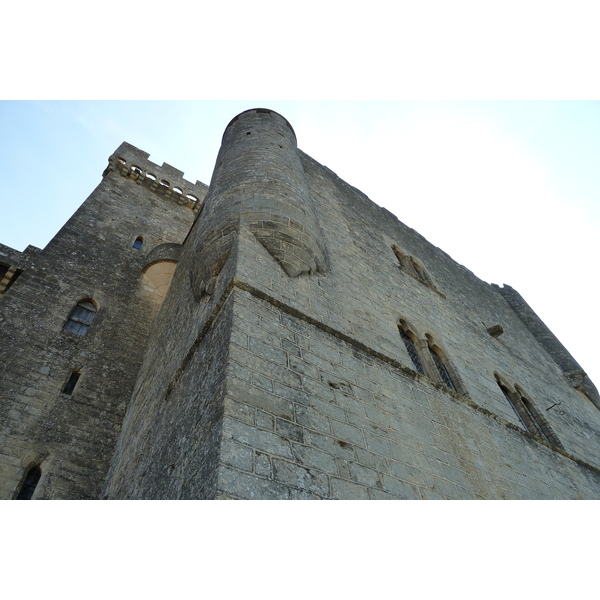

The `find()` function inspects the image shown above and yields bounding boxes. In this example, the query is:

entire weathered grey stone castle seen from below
[0,109,600,499]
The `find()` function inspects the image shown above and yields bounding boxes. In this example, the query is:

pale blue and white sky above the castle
[0,100,600,385]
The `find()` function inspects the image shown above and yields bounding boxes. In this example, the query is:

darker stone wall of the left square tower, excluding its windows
[0,144,206,499]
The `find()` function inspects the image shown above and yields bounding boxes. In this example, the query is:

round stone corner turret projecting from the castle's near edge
[192,108,326,296]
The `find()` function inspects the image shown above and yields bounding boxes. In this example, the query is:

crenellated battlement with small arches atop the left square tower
[102,142,208,212]
